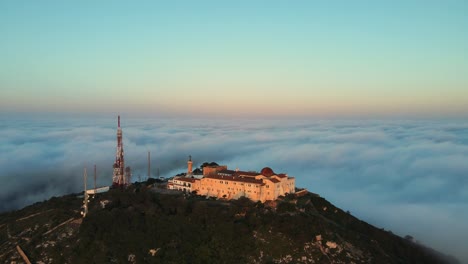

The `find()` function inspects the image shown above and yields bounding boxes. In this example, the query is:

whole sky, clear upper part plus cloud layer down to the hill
[0,0,468,263]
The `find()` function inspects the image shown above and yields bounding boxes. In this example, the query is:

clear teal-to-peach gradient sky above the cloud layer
[0,0,468,116]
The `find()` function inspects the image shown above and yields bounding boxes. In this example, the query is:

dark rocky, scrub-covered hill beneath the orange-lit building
[0,182,458,264]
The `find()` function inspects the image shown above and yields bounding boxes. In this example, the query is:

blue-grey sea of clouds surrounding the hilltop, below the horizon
[0,117,468,262]
